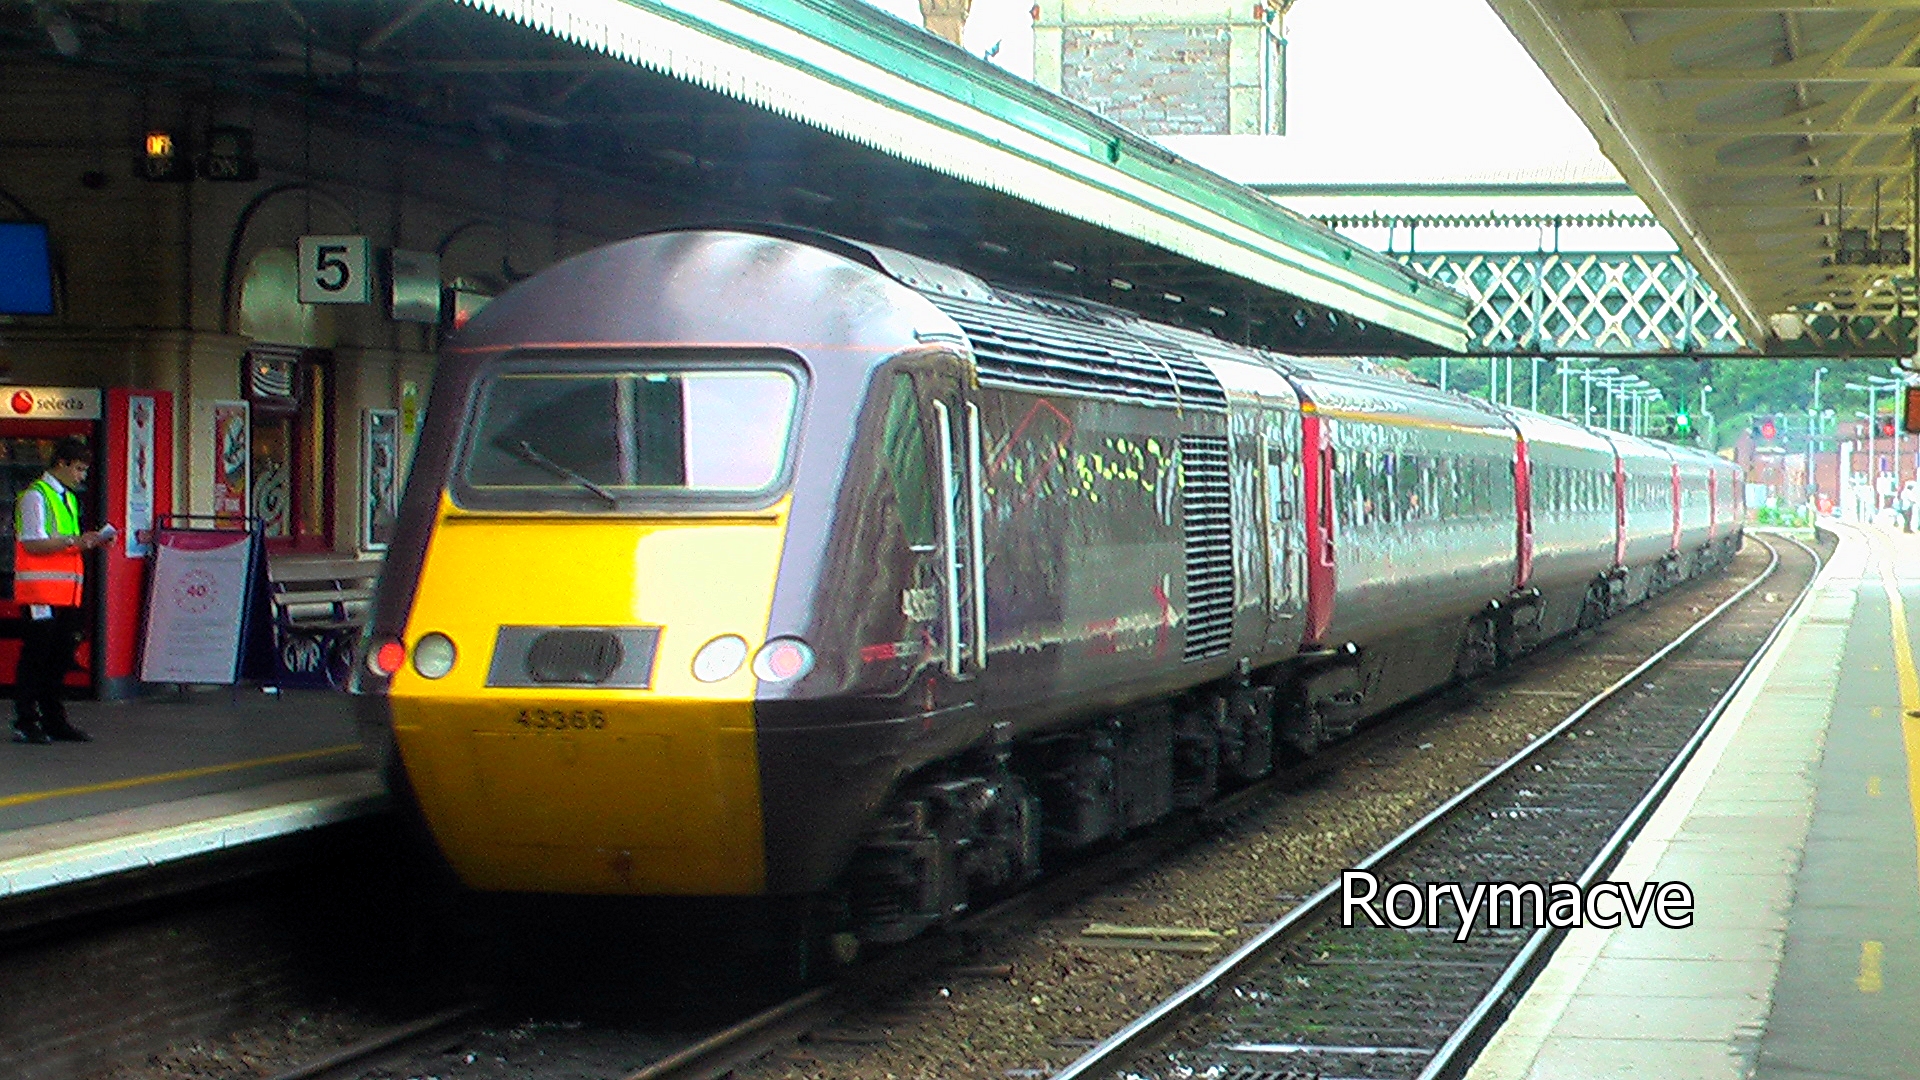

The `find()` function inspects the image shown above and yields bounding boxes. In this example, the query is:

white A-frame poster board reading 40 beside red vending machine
[140,528,253,682]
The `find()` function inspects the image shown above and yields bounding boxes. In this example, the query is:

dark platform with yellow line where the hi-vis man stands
[0,686,386,905]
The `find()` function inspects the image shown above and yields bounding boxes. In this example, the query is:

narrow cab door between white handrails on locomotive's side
[929,377,987,680]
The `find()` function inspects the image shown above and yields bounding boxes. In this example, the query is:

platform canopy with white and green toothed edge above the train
[0,0,1467,354]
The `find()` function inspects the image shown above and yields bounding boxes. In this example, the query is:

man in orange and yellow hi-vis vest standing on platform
[13,438,113,742]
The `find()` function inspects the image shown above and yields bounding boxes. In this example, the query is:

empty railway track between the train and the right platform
[1054,538,1820,1080]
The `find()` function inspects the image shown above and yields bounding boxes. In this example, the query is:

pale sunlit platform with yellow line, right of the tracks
[1469,525,1920,1080]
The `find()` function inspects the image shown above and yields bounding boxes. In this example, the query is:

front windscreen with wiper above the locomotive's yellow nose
[461,369,799,503]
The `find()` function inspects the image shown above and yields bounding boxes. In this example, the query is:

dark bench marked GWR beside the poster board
[267,555,380,690]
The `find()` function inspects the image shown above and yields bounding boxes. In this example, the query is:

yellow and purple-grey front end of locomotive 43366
[355,233,962,907]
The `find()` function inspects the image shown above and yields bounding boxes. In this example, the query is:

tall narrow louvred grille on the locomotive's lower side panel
[1181,434,1233,659]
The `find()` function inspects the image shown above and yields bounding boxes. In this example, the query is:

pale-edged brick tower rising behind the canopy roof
[1033,0,1290,135]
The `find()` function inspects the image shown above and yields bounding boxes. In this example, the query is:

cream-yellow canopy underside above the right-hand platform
[1490,0,1920,356]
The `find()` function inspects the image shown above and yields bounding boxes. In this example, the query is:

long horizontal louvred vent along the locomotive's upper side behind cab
[927,296,1227,413]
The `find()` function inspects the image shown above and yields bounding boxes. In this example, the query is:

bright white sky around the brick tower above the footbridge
[868,0,1672,252]
